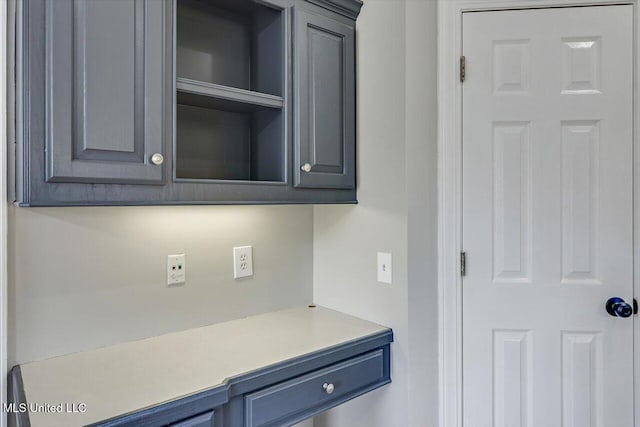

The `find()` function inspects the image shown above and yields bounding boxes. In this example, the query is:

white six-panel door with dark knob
[462,5,634,427]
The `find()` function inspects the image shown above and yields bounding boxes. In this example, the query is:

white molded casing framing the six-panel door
[437,0,640,427]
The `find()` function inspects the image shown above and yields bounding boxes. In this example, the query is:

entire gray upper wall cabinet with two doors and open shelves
[15,0,362,206]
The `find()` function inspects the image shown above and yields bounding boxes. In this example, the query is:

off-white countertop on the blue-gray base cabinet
[21,307,388,427]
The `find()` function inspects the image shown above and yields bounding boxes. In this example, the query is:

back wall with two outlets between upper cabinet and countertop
[9,206,313,364]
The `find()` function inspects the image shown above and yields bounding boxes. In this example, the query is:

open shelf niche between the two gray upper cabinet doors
[175,0,285,182]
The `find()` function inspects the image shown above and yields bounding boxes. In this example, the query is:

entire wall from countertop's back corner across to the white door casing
[314,0,438,427]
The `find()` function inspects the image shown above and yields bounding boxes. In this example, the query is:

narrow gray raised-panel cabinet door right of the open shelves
[293,9,355,189]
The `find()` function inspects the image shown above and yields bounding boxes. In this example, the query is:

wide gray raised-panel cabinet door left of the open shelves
[45,0,170,183]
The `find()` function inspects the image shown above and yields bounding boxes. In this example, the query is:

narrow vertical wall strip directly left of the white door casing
[405,0,439,427]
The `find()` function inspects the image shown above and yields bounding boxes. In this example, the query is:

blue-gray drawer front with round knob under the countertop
[245,350,388,427]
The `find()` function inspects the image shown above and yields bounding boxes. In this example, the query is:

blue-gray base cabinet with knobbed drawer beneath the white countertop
[9,330,393,427]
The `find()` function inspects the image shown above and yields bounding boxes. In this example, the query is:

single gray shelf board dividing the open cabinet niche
[176,77,284,113]
